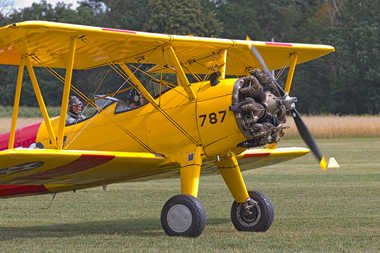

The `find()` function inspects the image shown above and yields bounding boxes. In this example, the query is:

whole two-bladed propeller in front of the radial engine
[251,45,327,170]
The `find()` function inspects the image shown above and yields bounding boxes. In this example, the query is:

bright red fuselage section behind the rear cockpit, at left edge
[0,122,42,151]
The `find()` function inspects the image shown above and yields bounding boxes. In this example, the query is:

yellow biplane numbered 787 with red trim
[0,21,334,237]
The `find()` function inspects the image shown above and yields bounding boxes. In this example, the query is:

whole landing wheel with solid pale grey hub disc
[161,194,206,237]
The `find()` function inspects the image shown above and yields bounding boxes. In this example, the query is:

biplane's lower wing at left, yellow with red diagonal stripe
[0,149,166,186]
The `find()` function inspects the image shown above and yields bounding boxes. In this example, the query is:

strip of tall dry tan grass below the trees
[0,115,380,139]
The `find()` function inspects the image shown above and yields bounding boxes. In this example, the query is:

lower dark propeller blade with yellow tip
[291,108,327,170]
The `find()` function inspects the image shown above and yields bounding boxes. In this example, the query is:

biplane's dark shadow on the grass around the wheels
[0,218,231,241]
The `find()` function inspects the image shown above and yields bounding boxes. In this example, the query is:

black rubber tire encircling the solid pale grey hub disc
[161,194,206,237]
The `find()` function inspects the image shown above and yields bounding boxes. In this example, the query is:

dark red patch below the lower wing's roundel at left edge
[0,184,49,198]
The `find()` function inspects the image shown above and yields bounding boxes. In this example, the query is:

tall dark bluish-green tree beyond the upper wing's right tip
[327,0,380,114]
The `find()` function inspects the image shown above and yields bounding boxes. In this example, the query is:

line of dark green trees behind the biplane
[0,0,380,115]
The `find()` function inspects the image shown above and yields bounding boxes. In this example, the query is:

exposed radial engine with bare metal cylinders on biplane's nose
[230,69,290,148]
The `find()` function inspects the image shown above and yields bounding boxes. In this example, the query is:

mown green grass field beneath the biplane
[0,138,380,252]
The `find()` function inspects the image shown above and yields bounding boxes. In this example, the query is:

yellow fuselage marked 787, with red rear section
[0,79,246,160]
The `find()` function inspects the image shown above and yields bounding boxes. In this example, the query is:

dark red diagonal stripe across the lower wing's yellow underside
[3,154,115,184]
